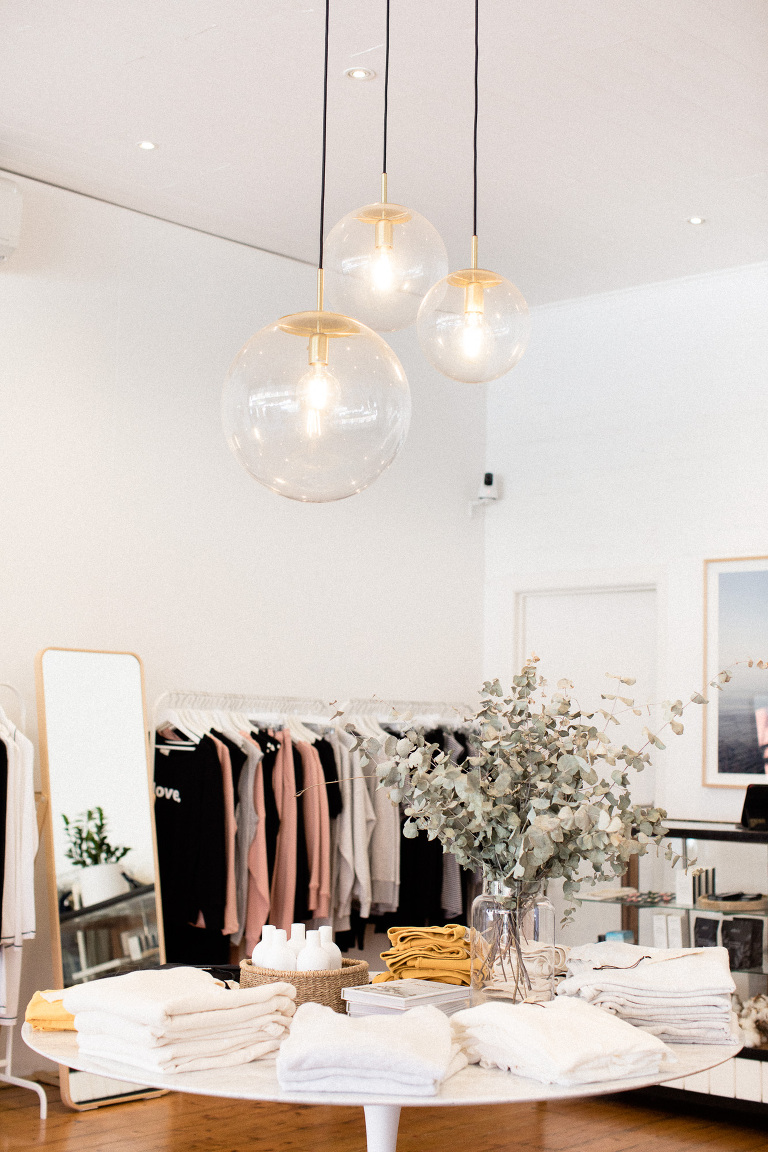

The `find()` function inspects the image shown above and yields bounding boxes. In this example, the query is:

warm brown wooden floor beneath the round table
[0,1087,768,1152]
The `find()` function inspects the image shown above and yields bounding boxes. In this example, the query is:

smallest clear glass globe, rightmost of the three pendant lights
[416,268,530,384]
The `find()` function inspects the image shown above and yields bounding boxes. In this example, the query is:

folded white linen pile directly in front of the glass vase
[450,999,676,1085]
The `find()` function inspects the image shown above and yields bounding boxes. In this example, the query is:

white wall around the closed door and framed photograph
[486,265,768,820]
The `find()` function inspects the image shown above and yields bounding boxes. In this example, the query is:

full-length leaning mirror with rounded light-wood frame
[36,649,165,1107]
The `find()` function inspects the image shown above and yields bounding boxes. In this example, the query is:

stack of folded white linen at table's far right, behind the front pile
[557,941,739,1044]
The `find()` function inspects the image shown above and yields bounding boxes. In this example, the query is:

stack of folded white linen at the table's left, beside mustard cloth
[63,968,296,1073]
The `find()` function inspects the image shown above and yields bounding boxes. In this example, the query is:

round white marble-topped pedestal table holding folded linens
[22,1024,740,1152]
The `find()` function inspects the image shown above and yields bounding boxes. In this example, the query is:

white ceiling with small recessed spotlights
[0,0,768,304]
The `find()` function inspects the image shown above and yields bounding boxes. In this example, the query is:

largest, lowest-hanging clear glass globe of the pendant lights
[221,312,411,503]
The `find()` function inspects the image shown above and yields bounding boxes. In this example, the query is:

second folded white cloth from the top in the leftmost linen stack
[75,996,296,1047]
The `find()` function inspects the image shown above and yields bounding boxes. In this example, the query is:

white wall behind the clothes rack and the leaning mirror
[0,180,485,1066]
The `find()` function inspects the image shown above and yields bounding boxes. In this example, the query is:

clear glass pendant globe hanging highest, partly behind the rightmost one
[324,204,448,332]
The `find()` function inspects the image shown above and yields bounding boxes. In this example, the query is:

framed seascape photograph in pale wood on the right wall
[702,556,768,788]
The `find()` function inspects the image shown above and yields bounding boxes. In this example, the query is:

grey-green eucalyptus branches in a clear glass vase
[350,657,704,999]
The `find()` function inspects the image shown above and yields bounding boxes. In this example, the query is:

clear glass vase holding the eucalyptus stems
[470,880,555,1005]
